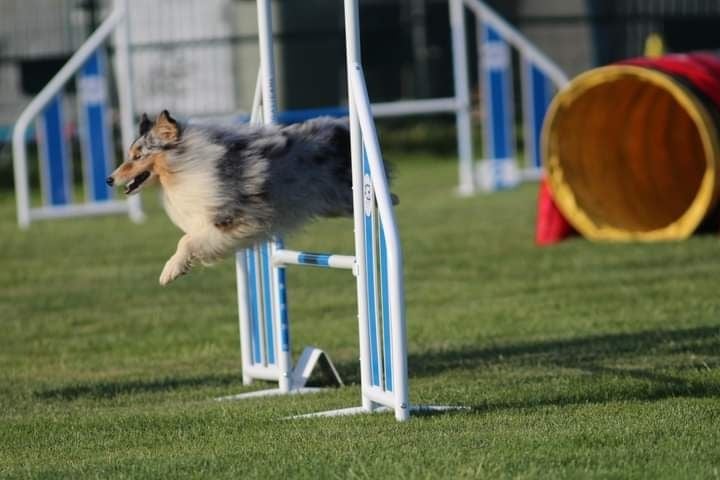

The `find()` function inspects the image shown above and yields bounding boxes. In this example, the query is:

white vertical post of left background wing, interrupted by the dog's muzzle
[114,0,145,222]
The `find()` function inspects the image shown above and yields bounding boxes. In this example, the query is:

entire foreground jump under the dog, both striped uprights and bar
[223,0,410,421]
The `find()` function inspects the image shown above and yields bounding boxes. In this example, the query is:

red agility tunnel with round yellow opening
[538,53,720,243]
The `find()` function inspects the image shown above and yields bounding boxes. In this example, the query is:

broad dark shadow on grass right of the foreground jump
[400,327,720,412]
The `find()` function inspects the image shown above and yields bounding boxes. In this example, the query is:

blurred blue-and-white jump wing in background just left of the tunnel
[448,0,568,194]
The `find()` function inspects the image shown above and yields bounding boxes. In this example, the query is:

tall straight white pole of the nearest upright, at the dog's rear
[344,0,377,411]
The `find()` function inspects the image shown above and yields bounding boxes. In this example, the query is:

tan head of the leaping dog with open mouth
[107,110,181,195]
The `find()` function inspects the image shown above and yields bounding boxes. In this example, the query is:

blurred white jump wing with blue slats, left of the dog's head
[12,0,143,228]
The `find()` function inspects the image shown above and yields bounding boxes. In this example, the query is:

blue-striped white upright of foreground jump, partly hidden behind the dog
[219,4,342,400]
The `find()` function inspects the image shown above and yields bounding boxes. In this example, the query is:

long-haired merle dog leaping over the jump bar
[107,110,388,285]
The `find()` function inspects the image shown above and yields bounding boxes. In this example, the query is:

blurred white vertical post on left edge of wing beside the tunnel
[449,0,476,195]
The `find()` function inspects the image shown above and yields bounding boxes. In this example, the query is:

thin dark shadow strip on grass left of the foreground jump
[34,373,242,401]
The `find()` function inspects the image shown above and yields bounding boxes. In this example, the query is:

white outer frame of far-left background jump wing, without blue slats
[12,0,143,228]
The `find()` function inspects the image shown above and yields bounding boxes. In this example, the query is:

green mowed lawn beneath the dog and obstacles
[0,153,720,479]
